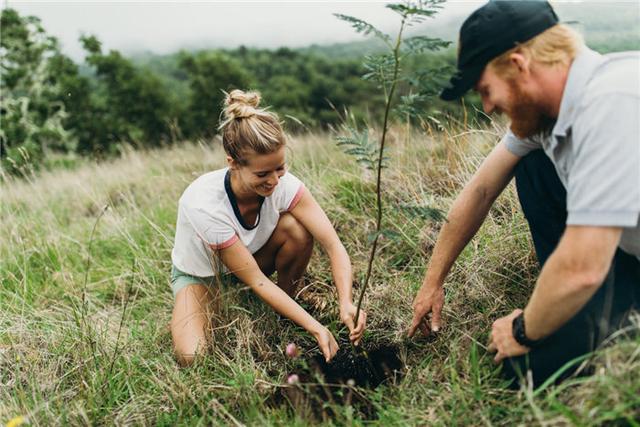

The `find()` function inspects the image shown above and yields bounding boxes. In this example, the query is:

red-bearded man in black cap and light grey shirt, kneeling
[409,1,640,385]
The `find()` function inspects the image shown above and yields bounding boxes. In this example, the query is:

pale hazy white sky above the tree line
[0,0,483,60]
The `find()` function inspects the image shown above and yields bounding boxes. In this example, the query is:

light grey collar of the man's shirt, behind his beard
[552,47,605,137]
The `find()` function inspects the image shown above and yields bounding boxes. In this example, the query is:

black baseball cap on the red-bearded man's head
[440,0,558,101]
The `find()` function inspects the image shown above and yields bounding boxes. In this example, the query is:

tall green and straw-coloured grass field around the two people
[0,123,640,426]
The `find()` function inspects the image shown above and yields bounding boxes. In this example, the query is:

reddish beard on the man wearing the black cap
[507,79,555,138]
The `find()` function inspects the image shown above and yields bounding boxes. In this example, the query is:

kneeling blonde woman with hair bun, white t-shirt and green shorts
[171,90,366,365]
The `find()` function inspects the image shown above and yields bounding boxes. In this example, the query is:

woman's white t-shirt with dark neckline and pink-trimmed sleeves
[171,168,304,277]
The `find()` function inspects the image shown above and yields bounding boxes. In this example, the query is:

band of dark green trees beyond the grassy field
[0,8,455,174]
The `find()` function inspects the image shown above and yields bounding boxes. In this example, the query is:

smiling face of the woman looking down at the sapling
[230,145,287,197]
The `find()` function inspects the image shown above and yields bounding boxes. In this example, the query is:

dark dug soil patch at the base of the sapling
[271,342,404,420]
